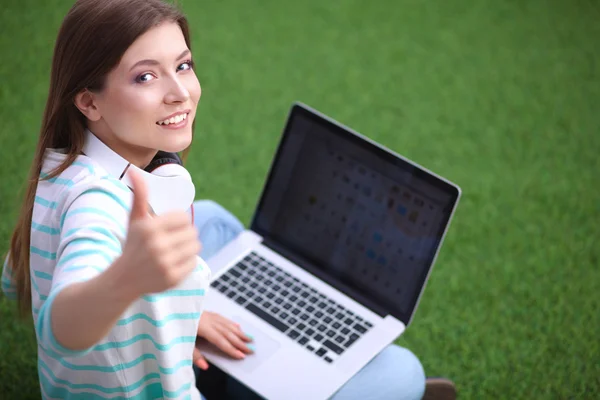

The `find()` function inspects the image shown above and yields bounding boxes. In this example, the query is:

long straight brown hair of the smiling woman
[9,0,191,315]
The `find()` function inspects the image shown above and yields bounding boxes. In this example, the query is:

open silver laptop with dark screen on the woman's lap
[198,103,461,400]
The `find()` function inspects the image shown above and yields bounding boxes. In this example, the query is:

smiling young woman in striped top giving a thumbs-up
[2,0,454,399]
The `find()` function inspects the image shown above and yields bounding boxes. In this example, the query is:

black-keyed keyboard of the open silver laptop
[210,252,373,363]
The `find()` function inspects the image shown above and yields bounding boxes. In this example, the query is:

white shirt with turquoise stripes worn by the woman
[2,150,210,399]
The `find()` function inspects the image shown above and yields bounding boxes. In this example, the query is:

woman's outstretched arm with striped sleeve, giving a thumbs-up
[44,170,200,355]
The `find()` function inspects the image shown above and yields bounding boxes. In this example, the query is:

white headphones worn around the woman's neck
[83,129,196,215]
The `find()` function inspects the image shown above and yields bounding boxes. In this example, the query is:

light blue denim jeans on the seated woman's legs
[194,200,425,400]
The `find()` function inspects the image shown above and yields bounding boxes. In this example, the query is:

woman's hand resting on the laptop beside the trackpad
[194,311,254,370]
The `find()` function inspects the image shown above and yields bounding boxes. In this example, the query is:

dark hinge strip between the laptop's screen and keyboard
[262,238,390,318]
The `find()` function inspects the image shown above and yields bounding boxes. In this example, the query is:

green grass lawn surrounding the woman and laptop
[0,0,600,399]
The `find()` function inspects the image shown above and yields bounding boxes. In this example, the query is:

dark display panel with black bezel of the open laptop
[252,105,459,324]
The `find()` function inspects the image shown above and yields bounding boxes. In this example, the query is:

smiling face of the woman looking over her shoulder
[88,22,201,167]
